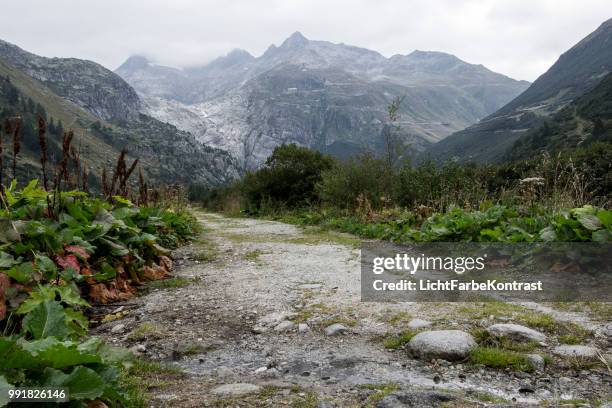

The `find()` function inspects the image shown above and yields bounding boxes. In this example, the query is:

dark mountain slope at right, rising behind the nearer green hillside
[426,19,612,162]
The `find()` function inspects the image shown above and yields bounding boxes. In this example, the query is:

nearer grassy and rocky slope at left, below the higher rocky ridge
[0,60,237,188]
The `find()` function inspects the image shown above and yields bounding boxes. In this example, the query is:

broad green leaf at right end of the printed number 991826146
[43,366,105,400]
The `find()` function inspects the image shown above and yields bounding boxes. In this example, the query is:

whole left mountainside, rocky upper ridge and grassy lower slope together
[0,43,238,187]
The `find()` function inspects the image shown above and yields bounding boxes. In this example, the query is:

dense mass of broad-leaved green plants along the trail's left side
[0,180,197,406]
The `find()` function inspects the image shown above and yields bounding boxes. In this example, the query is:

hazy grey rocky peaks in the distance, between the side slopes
[116,29,528,168]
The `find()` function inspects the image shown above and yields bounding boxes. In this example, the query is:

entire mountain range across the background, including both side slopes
[0,16,612,185]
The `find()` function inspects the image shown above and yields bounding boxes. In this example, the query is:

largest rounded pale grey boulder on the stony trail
[408,330,477,361]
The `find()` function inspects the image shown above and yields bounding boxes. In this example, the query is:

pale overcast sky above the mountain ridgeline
[0,0,612,81]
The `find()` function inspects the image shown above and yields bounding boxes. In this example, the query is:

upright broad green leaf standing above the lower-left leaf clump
[23,300,70,339]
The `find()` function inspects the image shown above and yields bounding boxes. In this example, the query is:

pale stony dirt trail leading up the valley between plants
[96,212,610,407]
